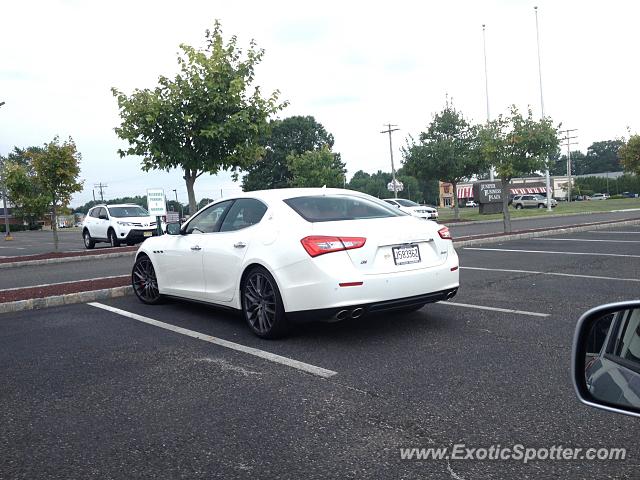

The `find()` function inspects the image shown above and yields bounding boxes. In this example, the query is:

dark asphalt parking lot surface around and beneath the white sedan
[0,227,640,479]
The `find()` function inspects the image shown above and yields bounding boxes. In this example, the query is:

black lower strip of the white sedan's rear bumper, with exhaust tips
[287,287,458,323]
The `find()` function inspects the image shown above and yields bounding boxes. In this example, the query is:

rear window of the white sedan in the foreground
[284,195,406,222]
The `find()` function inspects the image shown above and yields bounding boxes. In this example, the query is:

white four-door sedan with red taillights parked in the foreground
[132,188,459,338]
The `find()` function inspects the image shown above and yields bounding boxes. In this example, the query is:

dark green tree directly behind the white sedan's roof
[242,116,334,192]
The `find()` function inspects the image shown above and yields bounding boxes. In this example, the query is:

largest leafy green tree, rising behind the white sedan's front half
[112,21,286,214]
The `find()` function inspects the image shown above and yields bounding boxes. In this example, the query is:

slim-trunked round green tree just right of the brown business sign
[478,106,559,233]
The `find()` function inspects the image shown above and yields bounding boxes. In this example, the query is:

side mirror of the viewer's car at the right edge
[572,301,640,417]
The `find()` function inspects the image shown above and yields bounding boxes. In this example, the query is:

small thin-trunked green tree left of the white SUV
[32,136,82,251]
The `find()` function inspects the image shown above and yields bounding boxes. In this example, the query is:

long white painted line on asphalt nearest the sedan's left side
[87,302,338,378]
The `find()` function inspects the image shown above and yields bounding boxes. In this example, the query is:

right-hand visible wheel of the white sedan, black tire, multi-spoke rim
[240,267,289,338]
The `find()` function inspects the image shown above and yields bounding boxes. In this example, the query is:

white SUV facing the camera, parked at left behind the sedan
[82,204,156,249]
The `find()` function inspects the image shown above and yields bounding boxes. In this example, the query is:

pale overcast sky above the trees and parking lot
[0,0,640,206]
